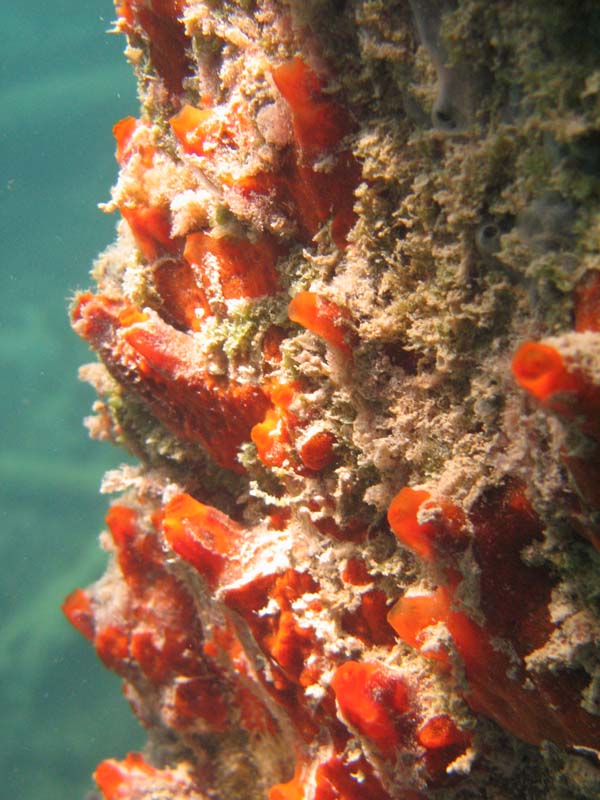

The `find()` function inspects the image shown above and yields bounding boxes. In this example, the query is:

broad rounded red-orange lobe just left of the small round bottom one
[331,661,410,756]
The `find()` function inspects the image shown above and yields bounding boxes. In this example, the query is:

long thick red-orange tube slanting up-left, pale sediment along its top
[72,293,269,473]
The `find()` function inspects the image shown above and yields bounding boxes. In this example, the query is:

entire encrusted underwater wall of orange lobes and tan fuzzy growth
[63,0,600,800]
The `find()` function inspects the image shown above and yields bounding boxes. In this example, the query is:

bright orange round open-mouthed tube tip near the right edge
[512,342,578,405]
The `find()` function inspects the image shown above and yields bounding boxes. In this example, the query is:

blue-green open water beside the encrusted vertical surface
[0,0,143,800]
